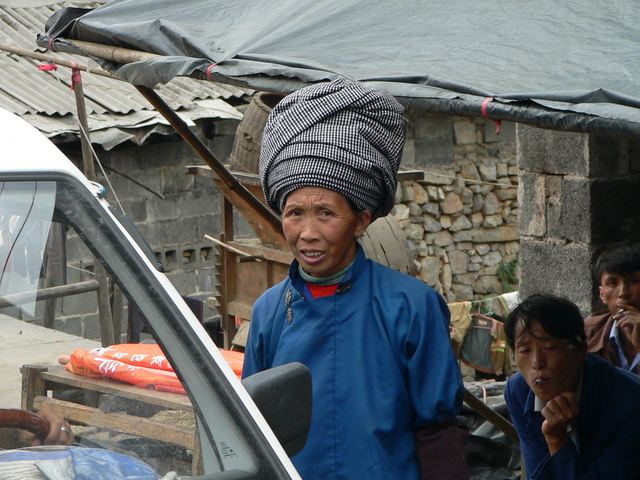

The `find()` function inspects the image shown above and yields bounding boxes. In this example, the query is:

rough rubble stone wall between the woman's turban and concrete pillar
[392,115,519,302]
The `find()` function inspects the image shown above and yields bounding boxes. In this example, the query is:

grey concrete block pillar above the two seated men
[517,125,640,315]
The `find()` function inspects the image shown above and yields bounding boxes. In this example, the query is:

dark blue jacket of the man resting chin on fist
[505,354,640,480]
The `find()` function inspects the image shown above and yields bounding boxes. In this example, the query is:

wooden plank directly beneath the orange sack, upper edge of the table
[40,366,193,411]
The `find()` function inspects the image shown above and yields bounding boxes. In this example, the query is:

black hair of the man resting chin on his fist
[504,294,587,349]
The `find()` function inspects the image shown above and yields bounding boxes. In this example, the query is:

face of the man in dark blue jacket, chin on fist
[515,322,586,400]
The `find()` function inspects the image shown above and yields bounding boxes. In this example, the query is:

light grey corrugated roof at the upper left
[0,2,251,145]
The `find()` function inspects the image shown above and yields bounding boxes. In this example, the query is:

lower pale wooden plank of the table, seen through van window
[34,396,195,449]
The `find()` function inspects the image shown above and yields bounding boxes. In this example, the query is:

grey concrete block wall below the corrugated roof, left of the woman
[56,120,239,341]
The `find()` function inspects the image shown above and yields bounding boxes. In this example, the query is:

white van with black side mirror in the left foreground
[0,109,311,479]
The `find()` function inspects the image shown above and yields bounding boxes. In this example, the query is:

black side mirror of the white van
[242,362,312,457]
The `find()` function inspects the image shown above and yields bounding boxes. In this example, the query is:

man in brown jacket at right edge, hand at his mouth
[585,244,640,374]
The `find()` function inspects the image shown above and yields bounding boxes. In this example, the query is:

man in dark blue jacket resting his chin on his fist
[505,295,640,480]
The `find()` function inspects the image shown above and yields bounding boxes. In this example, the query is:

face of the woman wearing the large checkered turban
[282,187,371,277]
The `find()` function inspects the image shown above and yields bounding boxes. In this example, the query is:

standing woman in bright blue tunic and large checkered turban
[243,79,469,480]
